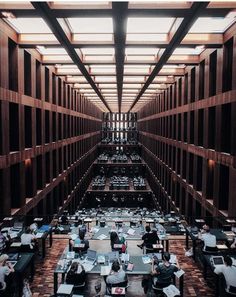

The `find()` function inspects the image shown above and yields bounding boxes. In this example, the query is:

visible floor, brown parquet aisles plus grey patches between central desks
[31,235,214,297]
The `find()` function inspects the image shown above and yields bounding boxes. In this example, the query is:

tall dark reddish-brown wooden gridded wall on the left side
[0,20,102,216]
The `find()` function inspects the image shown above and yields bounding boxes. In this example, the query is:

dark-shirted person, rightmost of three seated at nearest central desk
[151,252,179,288]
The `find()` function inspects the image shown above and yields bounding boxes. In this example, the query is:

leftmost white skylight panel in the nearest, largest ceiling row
[5,18,52,34]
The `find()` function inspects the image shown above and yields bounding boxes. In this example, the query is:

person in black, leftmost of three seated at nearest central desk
[66,262,86,286]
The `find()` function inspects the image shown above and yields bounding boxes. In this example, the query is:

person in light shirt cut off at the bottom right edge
[214,256,236,293]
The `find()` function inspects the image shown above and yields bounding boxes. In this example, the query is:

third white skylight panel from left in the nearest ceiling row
[127,18,175,33]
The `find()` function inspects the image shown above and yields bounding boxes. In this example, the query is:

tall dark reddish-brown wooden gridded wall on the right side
[138,23,236,222]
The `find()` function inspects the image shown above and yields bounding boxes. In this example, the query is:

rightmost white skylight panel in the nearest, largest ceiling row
[189,17,236,33]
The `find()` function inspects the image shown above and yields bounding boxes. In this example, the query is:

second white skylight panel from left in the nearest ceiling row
[68,18,113,33]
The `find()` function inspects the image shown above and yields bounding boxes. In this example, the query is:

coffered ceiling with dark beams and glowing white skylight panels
[0,1,236,112]
